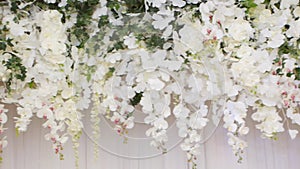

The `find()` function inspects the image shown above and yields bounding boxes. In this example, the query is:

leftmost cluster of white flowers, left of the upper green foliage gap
[1,10,82,160]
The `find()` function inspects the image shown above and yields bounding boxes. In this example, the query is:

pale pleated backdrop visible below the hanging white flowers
[0,105,300,169]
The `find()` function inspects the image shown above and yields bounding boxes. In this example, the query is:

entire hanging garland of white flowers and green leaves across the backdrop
[0,0,300,167]
